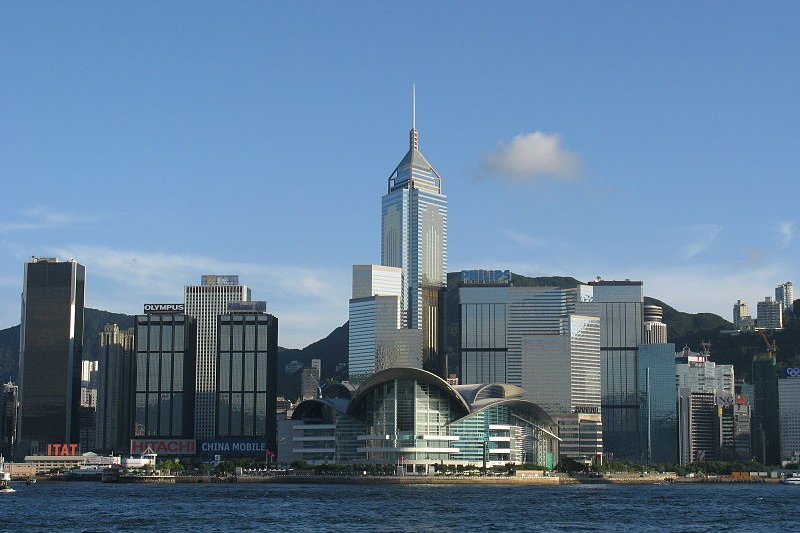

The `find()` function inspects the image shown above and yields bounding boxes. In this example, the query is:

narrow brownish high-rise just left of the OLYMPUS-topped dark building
[96,324,135,452]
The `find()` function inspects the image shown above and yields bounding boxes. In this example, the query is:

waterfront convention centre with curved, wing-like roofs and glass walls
[292,368,559,473]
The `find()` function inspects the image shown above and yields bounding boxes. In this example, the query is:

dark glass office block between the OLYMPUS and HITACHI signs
[132,313,197,438]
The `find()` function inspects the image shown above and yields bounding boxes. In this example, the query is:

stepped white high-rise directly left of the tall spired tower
[348,265,422,383]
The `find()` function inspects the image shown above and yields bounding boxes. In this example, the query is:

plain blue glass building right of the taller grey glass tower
[638,343,678,464]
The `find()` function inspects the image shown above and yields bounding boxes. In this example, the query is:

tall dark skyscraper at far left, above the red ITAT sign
[18,257,86,454]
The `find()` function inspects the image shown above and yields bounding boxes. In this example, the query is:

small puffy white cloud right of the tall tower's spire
[482,131,581,182]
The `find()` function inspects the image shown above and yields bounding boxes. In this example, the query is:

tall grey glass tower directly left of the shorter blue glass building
[589,280,644,461]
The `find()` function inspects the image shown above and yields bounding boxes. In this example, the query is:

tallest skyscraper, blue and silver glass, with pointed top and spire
[381,88,447,377]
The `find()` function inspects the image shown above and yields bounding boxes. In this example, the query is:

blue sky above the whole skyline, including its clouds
[0,1,800,347]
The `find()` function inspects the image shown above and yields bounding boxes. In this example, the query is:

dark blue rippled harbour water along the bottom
[0,482,800,533]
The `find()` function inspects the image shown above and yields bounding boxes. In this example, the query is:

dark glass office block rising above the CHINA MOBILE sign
[216,302,278,451]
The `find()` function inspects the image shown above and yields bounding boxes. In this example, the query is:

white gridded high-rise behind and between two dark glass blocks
[184,275,250,439]
